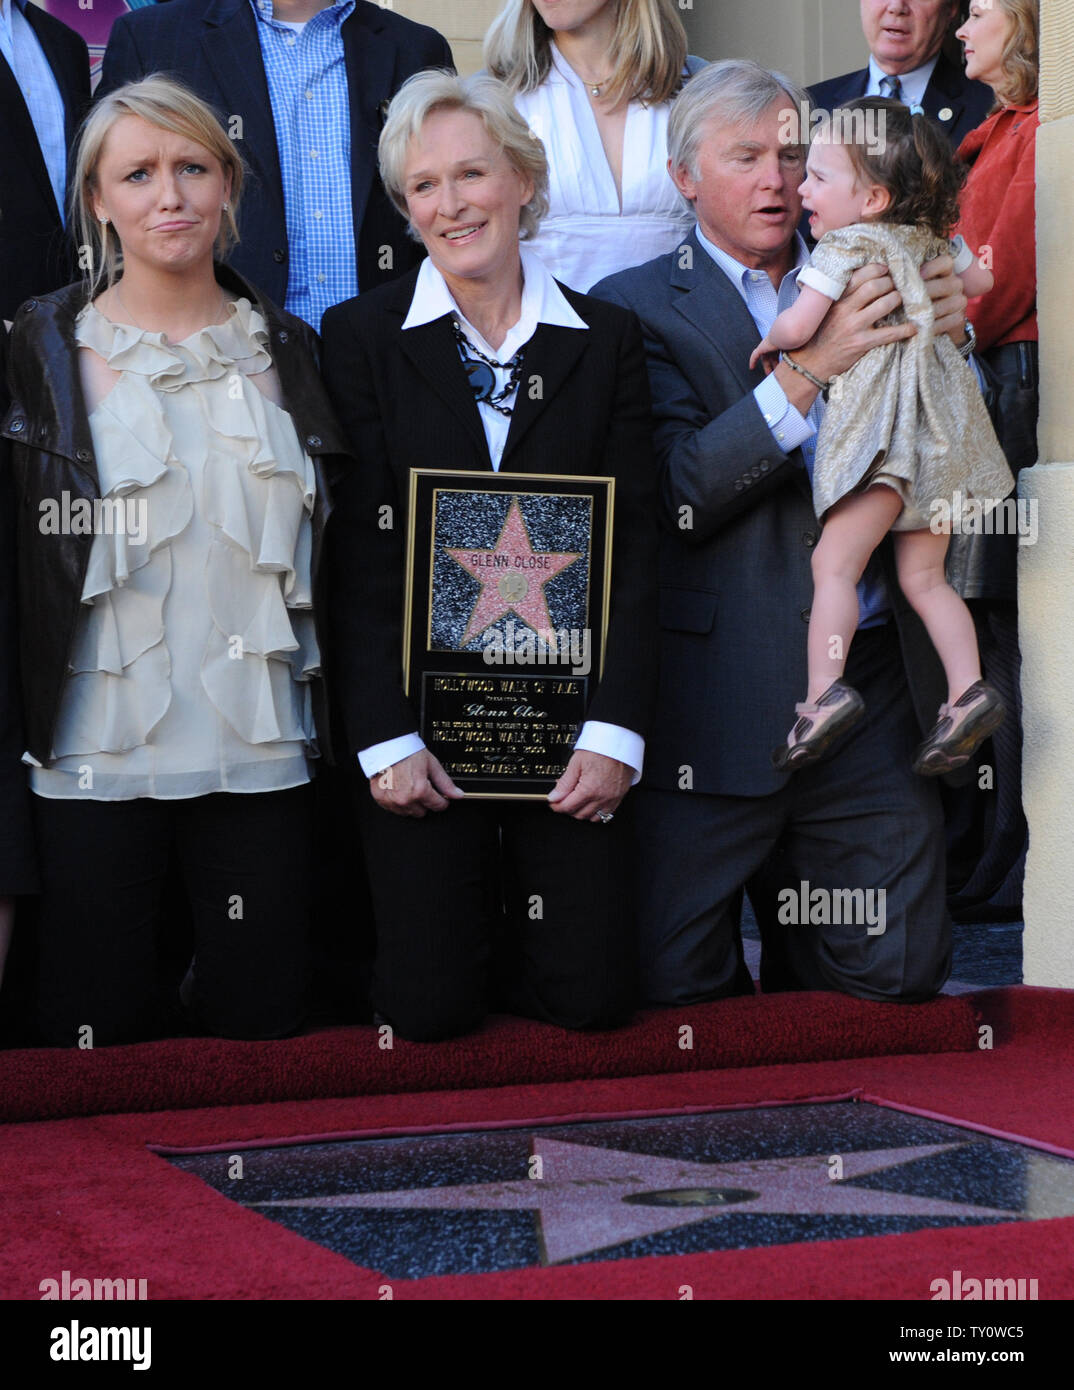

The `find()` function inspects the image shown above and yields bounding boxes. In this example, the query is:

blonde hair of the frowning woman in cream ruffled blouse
[71,72,243,297]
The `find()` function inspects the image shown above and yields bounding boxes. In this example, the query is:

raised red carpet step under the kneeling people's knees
[0,992,977,1120]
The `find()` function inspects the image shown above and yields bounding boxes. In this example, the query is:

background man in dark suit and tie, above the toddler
[809,0,995,149]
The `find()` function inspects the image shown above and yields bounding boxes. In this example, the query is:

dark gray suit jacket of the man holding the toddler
[592,232,945,796]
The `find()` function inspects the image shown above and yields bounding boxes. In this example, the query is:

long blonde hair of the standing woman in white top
[484,0,686,106]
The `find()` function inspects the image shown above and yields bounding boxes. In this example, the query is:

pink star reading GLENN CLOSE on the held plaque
[445,498,581,646]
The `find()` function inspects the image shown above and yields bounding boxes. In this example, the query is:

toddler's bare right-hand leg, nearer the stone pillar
[895,531,981,705]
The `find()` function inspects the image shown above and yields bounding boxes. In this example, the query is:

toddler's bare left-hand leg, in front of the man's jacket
[806,484,903,705]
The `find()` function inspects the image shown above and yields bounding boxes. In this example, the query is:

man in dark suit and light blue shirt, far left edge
[0,0,89,320]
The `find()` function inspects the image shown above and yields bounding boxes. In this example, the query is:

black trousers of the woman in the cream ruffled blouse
[32,785,311,1047]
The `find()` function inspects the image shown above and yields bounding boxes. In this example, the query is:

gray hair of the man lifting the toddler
[667,58,809,179]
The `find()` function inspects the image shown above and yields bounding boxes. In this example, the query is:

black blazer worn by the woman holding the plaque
[322,271,657,752]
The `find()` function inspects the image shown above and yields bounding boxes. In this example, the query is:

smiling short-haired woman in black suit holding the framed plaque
[324,72,656,1040]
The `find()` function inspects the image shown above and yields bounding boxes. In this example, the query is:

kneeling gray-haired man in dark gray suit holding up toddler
[592,61,966,1004]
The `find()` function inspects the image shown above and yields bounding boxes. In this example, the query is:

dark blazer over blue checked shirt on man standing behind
[97,0,453,304]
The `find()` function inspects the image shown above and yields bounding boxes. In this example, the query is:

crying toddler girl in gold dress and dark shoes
[750,97,1014,776]
